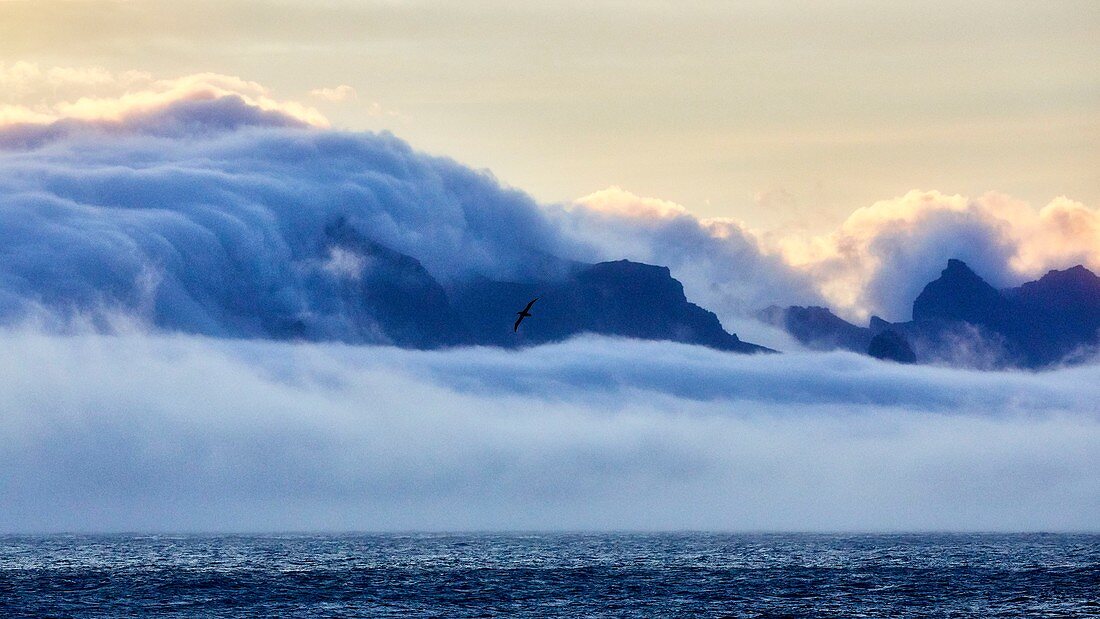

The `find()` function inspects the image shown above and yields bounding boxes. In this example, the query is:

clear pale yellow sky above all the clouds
[0,0,1100,229]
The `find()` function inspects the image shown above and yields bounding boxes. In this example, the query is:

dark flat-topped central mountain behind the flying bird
[319,221,768,353]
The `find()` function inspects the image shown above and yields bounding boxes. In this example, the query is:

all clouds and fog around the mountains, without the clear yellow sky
[0,66,1100,531]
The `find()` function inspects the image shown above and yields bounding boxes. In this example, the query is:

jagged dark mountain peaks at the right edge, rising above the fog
[760,259,1100,368]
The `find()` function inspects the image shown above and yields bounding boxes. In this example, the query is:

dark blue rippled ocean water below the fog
[0,533,1100,618]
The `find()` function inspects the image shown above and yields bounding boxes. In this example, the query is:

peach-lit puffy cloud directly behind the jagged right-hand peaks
[772,190,1100,320]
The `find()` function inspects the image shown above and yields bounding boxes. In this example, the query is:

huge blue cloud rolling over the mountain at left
[0,96,579,340]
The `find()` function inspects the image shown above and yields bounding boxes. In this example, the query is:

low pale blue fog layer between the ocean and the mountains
[0,330,1100,532]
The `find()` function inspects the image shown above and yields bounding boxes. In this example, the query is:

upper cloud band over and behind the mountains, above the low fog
[0,68,1100,338]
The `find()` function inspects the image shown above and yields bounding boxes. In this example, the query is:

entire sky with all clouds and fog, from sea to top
[0,0,1100,532]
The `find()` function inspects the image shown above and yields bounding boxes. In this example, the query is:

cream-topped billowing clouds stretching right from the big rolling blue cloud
[567,187,1100,327]
